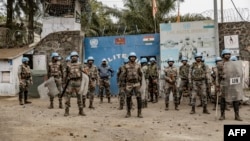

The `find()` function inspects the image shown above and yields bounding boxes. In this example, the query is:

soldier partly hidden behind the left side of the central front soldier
[117,58,128,110]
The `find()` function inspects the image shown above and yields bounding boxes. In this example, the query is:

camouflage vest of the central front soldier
[125,64,141,83]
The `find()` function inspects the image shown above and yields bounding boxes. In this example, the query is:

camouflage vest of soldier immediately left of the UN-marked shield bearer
[191,62,206,81]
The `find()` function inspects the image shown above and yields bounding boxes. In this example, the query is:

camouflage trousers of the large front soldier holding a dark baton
[65,79,83,108]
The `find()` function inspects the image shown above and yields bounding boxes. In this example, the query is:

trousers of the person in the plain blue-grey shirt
[99,79,111,98]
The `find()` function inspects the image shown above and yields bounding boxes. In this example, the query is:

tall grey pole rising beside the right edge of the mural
[214,0,220,56]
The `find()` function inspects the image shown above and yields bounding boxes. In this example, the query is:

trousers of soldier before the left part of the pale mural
[165,83,178,104]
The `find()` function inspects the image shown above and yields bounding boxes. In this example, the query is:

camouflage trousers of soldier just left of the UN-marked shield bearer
[191,80,207,106]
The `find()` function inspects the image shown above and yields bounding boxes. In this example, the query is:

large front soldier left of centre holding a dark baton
[64,51,86,116]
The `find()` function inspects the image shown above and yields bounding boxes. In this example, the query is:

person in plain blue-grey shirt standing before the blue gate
[98,59,114,103]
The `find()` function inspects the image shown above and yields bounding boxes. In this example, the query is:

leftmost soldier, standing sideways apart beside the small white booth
[18,57,33,105]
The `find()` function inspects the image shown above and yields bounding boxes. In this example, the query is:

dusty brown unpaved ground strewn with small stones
[0,97,250,141]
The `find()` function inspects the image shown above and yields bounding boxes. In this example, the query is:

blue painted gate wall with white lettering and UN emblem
[83,34,160,95]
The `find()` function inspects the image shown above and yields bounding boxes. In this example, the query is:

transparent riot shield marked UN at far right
[222,61,243,102]
